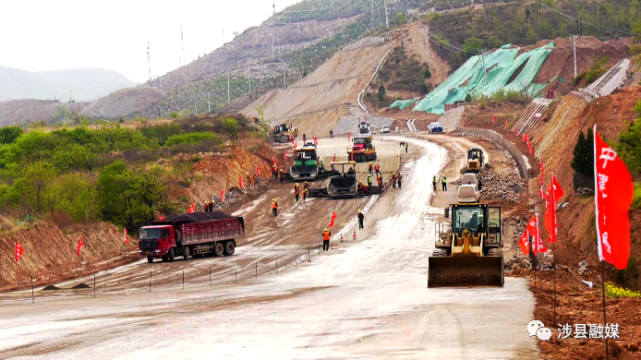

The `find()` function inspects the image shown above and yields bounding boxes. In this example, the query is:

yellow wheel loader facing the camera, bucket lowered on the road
[427,203,505,287]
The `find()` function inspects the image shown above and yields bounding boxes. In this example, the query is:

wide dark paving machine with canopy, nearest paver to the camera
[309,161,384,198]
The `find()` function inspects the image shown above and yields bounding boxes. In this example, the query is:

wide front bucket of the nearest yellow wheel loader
[427,255,504,287]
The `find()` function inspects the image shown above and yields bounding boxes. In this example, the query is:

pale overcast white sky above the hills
[0,0,300,82]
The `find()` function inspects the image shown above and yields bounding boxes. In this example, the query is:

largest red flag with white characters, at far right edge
[594,125,634,270]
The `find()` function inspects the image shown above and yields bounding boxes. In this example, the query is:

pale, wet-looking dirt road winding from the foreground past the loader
[0,137,538,359]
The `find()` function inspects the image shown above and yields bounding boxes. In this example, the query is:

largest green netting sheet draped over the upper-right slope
[412,43,554,114]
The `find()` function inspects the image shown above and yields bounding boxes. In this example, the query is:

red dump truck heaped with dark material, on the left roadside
[138,211,245,263]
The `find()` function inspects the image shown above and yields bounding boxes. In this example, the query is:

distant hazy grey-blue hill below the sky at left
[0,66,134,101]
